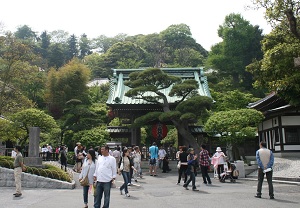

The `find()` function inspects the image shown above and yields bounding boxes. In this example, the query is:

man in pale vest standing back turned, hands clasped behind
[255,142,274,199]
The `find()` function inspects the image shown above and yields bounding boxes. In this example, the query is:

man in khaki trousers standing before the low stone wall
[13,146,26,197]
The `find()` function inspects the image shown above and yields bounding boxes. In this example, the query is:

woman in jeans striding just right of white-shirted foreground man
[118,149,136,197]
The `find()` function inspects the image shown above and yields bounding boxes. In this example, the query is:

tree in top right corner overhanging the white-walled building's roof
[247,0,300,106]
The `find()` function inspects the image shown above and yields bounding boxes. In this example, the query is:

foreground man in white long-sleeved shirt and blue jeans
[94,146,117,208]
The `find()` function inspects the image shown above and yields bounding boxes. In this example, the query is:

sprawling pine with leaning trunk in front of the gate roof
[124,68,212,149]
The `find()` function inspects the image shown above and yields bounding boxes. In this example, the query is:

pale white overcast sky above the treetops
[0,0,271,50]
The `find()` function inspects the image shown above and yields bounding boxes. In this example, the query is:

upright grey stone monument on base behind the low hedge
[24,127,42,167]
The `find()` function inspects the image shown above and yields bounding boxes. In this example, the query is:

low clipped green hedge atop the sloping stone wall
[0,156,72,182]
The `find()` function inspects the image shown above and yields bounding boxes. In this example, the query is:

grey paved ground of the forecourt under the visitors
[0,171,300,208]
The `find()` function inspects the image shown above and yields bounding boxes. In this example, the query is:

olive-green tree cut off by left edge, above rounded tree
[0,33,35,115]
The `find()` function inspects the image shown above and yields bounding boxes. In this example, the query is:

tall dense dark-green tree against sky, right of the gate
[207,13,263,90]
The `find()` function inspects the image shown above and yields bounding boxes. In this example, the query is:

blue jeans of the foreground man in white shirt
[94,181,111,208]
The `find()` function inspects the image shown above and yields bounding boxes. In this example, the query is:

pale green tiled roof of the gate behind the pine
[106,68,211,106]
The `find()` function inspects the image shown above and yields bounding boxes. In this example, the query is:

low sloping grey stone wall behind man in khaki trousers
[0,167,75,189]
